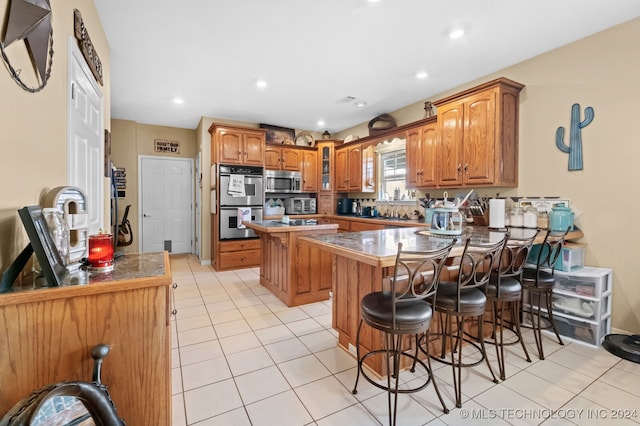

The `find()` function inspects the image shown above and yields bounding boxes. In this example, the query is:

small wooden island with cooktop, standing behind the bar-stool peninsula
[245,219,338,306]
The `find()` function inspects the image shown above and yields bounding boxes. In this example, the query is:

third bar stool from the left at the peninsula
[485,229,539,380]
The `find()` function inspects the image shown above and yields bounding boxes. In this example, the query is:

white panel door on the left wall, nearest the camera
[68,38,102,235]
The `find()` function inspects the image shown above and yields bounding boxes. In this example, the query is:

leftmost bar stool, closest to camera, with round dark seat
[352,240,456,425]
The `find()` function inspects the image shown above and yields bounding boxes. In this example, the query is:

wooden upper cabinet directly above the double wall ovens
[209,124,266,166]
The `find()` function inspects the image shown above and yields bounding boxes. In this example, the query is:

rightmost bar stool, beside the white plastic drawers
[522,228,569,359]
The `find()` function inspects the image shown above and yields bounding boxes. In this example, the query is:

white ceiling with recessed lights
[94,0,640,133]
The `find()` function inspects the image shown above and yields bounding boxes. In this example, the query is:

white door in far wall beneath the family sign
[139,157,193,254]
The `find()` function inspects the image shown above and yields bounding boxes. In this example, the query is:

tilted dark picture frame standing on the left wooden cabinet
[18,206,67,287]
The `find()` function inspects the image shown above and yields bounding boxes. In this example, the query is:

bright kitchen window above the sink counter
[376,138,407,200]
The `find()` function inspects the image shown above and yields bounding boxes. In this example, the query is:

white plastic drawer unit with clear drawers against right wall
[523,266,613,346]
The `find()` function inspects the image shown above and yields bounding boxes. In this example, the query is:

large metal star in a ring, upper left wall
[0,0,53,93]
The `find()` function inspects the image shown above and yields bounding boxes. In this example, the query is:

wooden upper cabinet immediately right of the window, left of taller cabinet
[407,118,438,188]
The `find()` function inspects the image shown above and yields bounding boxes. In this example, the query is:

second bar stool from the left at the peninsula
[428,234,509,408]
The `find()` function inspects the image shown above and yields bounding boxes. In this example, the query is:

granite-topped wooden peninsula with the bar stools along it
[299,226,582,375]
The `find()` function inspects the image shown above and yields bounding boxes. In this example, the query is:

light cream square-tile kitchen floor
[171,255,640,426]
